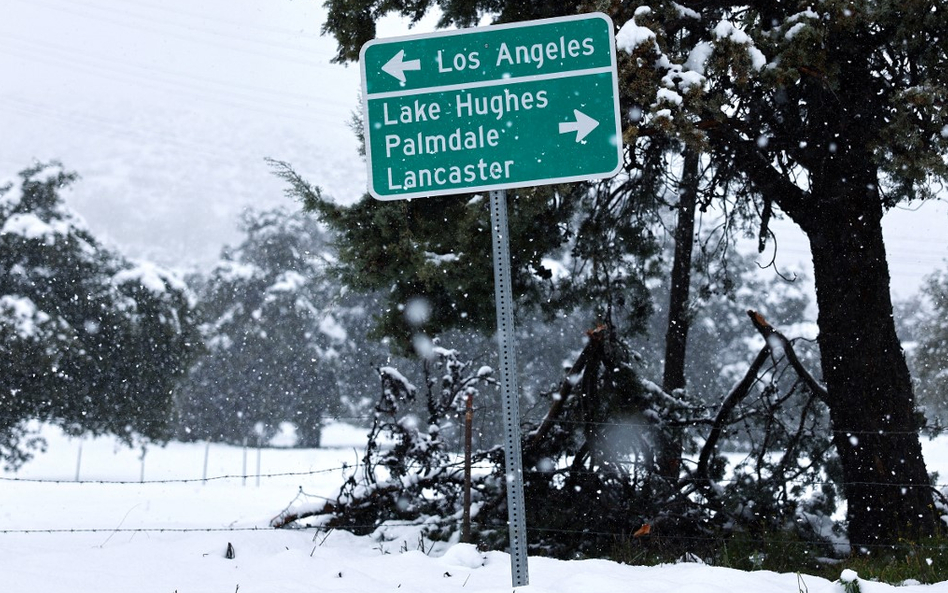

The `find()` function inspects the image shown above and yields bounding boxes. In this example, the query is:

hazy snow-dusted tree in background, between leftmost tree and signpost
[178,209,362,446]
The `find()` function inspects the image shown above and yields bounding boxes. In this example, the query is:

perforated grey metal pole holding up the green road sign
[490,189,530,587]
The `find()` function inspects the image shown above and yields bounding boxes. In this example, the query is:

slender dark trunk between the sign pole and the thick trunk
[656,148,698,483]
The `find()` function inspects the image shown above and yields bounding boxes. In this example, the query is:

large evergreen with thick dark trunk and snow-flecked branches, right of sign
[316,0,948,549]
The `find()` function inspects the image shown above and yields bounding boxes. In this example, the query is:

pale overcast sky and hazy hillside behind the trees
[0,0,948,297]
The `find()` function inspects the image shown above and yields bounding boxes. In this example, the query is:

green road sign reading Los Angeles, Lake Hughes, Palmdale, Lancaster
[360,13,622,200]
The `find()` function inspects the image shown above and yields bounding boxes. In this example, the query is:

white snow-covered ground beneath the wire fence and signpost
[0,426,948,593]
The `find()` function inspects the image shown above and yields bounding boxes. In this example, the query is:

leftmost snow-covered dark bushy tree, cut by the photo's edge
[0,164,197,465]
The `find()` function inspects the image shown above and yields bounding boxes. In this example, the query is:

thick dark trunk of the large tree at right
[794,188,937,552]
